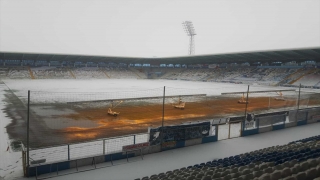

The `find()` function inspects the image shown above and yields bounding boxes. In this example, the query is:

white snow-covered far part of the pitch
[4,79,298,101]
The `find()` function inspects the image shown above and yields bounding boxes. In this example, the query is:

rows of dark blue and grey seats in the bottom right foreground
[135,135,320,180]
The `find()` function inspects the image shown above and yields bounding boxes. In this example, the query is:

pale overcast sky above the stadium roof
[0,0,320,57]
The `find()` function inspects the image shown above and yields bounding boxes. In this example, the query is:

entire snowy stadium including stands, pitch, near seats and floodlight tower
[0,0,320,180]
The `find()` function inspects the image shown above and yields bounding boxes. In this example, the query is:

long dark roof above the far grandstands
[0,47,320,64]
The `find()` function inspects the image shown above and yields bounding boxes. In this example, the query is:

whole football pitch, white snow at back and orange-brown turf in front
[4,79,320,148]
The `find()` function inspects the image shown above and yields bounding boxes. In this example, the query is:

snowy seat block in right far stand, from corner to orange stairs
[160,66,297,85]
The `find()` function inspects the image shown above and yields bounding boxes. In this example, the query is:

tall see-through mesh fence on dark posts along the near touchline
[21,87,320,167]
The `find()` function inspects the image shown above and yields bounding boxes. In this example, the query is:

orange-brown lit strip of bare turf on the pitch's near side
[57,97,320,143]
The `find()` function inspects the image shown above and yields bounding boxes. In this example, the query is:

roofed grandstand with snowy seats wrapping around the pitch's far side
[0,47,320,88]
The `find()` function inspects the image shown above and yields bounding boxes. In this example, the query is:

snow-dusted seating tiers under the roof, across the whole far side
[0,60,320,89]
